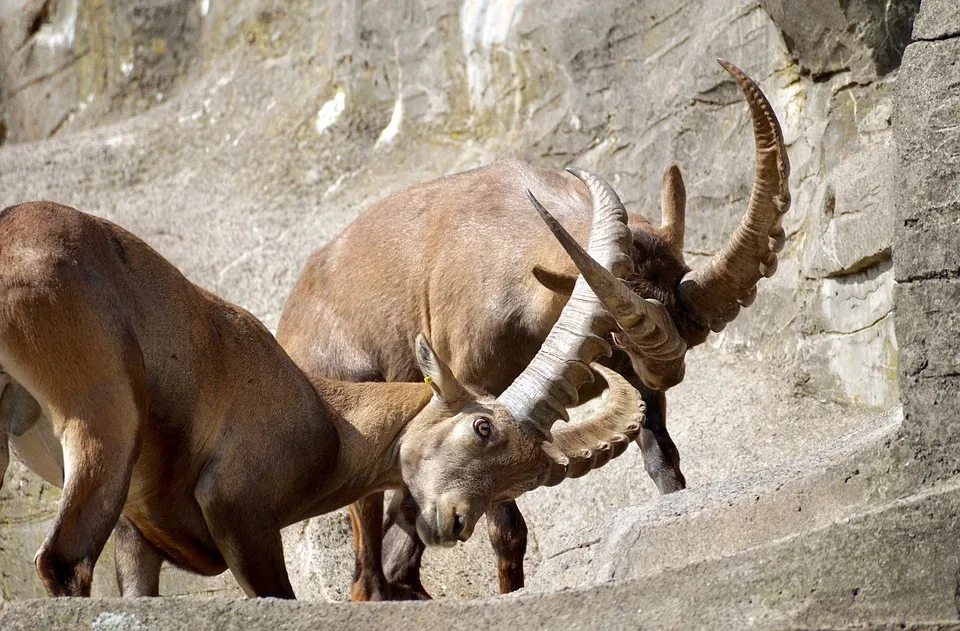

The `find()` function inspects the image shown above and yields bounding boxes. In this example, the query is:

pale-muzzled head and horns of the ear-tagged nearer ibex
[400,171,644,545]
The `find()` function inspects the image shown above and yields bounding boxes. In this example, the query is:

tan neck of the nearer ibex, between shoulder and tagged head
[311,377,431,510]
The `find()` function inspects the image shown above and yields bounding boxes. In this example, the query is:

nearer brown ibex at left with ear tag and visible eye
[0,167,642,597]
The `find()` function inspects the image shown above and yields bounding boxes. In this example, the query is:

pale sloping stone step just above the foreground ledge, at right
[528,409,902,592]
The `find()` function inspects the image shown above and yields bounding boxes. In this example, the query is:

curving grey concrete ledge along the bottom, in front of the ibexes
[0,472,960,631]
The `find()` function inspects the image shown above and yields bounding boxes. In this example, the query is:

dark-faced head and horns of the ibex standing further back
[552,60,790,389]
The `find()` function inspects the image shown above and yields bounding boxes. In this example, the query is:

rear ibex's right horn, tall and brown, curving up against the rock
[678,59,790,331]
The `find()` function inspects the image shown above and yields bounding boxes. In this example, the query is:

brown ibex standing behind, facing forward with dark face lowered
[277,61,790,599]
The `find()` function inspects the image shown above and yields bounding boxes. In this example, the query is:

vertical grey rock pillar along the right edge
[894,8,960,482]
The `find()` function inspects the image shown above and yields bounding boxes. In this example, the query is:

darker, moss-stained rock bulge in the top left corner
[0,0,200,142]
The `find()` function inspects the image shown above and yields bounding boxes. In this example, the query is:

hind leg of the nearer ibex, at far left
[13,336,147,596]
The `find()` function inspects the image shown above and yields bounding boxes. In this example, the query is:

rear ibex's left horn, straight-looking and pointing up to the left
[530,183,687,368]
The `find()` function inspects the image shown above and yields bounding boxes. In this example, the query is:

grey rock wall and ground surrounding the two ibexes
[0,0,960,628]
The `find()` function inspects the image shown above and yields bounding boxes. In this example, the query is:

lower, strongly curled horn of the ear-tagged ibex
[541,364,646,486]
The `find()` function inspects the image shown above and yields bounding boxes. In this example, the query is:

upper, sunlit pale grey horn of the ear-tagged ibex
[497,169,632,440]
